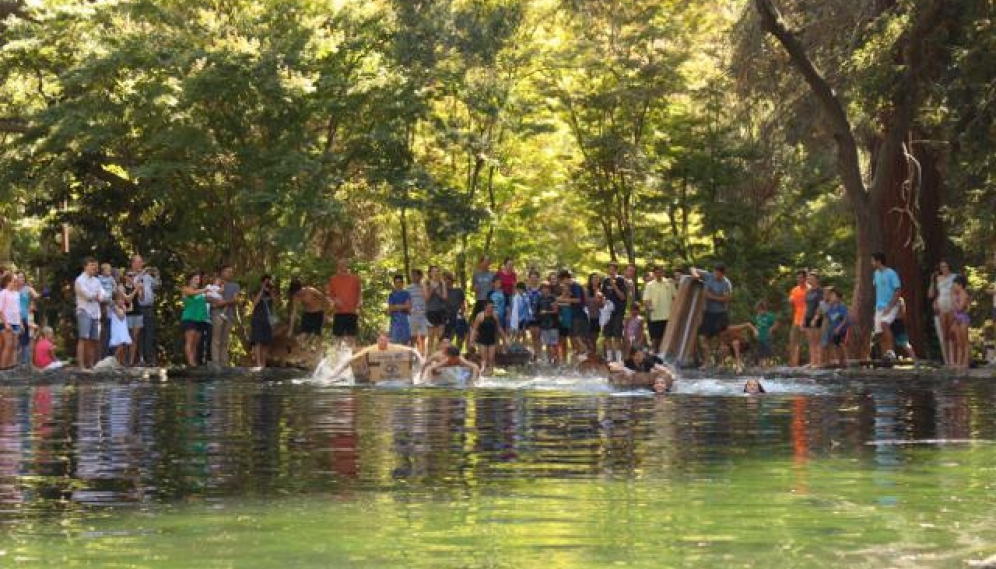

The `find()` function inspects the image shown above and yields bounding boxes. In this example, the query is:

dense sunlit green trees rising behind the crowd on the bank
[0,0,996,358]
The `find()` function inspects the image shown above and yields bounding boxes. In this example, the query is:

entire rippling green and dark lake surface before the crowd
[0,378,996,569]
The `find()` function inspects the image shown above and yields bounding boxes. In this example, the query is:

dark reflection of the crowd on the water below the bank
[0,381,996,523]
